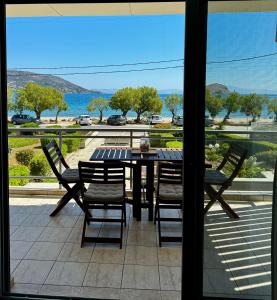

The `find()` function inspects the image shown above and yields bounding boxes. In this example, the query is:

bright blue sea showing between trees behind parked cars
[9,93,277,118]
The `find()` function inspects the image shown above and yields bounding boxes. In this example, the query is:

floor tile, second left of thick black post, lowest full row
[122,265,160,290]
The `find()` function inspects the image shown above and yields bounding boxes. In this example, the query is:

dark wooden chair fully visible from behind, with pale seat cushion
[79,162,126,249]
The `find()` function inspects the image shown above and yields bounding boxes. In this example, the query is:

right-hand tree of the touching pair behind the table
[133,86,163,123]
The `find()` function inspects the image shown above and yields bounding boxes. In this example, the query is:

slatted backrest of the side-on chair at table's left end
[42,140,69,180]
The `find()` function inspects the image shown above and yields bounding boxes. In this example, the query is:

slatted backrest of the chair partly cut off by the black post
[157,163,183,193]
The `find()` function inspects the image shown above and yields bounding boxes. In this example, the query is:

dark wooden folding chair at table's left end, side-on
[42,140,84,217]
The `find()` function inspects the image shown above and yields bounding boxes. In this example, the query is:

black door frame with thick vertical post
[0,0,268,299]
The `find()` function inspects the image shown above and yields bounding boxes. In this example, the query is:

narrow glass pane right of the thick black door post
[203,1,277,299]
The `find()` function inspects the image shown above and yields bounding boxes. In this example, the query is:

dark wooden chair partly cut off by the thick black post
[154,163,183,247]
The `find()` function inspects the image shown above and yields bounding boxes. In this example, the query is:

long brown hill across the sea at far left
[8,70,99,94]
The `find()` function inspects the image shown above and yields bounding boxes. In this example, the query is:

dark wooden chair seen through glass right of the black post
[204,144,247,219]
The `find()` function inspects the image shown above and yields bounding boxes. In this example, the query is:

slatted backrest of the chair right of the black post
[217,144,247,183]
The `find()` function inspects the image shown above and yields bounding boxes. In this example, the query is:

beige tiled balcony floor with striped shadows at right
[10,198,271,300]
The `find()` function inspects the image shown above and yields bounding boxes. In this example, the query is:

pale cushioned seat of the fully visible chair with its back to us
[83,183,124,203]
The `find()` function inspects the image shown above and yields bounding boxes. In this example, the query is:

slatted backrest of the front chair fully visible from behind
[79,161,125,186]
